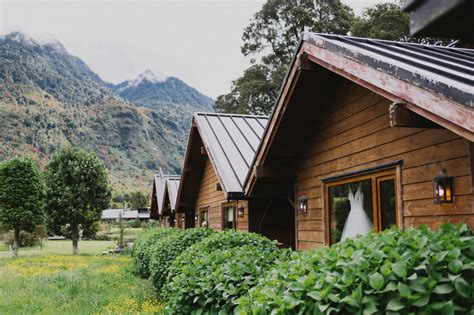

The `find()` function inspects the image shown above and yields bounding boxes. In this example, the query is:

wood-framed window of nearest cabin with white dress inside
[325,169,398,244]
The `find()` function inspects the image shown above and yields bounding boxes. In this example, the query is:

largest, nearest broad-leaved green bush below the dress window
[235,225,474,314]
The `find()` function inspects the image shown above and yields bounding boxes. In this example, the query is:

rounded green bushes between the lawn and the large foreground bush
[132,228,290,314]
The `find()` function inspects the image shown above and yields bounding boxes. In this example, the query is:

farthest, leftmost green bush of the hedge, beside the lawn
[132,228,179,278]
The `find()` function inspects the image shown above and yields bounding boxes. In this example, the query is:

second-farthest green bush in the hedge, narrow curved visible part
[149,228,217,292]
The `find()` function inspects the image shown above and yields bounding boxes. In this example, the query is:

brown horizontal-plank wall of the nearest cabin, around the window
[295,81,474,249]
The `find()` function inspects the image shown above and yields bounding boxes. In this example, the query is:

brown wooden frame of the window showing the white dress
[323,167,400,245]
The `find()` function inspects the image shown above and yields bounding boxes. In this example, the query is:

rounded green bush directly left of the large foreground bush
[164,244,289,314]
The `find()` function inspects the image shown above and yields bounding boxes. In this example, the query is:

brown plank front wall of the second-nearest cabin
[195,159,248,231]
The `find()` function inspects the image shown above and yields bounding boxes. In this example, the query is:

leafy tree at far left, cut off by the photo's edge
[0,158,45,256]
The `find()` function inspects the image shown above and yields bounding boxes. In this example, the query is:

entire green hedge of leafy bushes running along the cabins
[134,224,474,315]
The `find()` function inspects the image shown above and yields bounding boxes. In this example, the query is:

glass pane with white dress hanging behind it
[328,179,374,243]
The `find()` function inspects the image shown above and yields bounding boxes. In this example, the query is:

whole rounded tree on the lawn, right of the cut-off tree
[45,147,111,254]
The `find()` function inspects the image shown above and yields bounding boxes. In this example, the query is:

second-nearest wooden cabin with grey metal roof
[177,113,294,246]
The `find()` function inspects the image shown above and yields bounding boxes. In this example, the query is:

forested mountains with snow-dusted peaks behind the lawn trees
[0,32,210,193]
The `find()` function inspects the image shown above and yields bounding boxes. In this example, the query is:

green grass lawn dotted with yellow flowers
[0,254,161,314]
